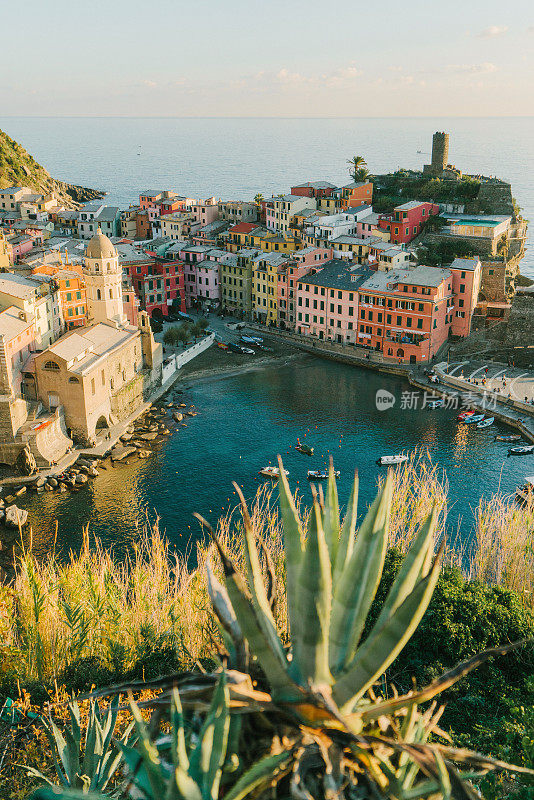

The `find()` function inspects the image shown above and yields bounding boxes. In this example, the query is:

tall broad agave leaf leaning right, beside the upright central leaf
[330,474,392,674]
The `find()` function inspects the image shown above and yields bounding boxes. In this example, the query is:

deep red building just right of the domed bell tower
[121,251,186,317]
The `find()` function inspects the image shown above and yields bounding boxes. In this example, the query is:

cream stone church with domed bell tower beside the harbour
[0,229,163,466]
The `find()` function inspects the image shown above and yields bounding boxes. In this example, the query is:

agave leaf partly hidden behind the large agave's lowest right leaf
[375,505,439,627]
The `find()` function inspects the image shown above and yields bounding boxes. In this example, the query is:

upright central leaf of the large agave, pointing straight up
[294,493,332,685]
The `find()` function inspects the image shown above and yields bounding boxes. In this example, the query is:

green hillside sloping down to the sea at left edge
[0,130,104,206]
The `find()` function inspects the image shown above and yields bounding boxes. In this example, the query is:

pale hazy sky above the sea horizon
[0,0,534,117]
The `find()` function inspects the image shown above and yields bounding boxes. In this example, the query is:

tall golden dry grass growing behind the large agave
[0,453,534,682]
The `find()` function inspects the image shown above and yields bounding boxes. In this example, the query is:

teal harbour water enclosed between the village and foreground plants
[25,356,532,564]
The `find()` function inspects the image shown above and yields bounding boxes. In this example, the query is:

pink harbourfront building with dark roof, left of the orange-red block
[295,258,372,344]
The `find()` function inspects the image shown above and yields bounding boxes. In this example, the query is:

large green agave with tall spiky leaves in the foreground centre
[199,460,441,713]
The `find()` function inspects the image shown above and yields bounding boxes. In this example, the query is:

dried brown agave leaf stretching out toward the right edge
[361,639,532,722]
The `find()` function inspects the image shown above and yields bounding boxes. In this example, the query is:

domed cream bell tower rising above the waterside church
[83,228,127,325]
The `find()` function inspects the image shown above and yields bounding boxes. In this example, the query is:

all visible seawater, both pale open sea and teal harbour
[0,118,534,559]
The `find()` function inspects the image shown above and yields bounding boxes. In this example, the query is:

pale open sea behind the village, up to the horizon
[0,112,534,277]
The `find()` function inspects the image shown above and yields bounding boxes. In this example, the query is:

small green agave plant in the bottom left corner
[24,695,133,794]
